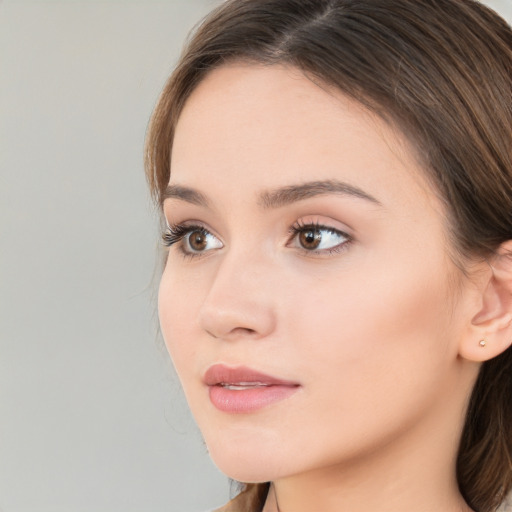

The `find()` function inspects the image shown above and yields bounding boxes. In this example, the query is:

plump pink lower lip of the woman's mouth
[209,385,299,414]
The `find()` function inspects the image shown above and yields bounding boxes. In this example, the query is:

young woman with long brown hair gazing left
[147,0,512,512]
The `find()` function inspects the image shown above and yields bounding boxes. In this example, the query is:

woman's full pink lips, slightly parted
[203,364,300,414]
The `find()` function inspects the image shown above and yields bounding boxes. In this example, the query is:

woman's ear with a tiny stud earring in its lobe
[459,240,512,362]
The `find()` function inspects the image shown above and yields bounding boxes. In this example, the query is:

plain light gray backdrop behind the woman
[0,0,512,512]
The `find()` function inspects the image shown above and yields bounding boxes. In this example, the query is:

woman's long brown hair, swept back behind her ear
[146,0,512,512]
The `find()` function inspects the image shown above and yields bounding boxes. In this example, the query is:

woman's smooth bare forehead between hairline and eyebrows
[170,63,440,214]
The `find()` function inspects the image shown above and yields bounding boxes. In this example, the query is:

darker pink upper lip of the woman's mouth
[203,364,299,387]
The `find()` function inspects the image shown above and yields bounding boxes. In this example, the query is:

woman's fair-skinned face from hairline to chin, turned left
[159,64,476,482]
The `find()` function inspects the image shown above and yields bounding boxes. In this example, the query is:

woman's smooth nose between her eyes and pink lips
[199,254,276,341]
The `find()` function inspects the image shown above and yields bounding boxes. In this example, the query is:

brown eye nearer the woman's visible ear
[290,224,351,253]
